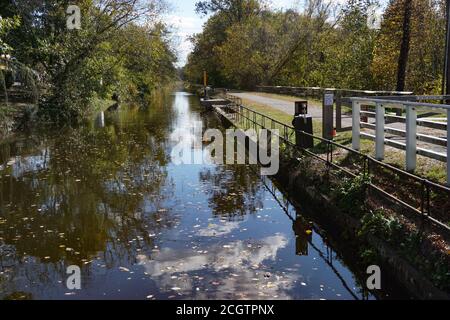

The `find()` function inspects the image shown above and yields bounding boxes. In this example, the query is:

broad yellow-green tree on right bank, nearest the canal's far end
[185,0,338,88]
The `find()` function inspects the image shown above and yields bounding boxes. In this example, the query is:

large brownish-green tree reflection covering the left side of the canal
[0,97,179,293]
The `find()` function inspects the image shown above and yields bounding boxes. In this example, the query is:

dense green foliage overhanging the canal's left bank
[2,0,176,122]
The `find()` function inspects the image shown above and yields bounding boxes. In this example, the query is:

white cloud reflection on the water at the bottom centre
[137,235,298,299]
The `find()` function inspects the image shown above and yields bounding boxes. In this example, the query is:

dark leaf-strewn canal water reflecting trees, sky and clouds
[0,92,380,300]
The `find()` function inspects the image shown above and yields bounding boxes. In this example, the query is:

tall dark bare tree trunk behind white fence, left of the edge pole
[396,0,412,115]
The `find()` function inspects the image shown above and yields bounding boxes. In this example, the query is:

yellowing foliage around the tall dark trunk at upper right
[372,0,445,94]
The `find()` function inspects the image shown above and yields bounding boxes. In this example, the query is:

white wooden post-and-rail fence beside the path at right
[350,96,450,186]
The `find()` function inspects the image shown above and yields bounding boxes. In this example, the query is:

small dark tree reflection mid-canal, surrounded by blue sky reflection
[200,165,264,220]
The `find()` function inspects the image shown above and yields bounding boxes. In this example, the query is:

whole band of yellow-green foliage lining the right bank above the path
[184,0,445,94]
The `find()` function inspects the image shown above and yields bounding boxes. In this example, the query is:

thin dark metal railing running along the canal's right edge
[222,95,450,233]
